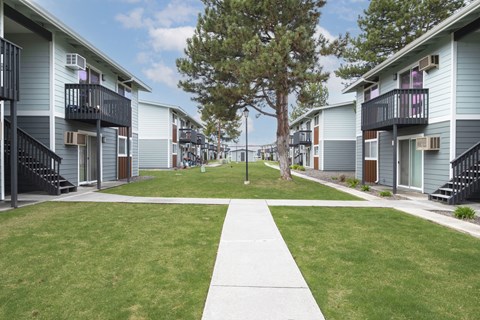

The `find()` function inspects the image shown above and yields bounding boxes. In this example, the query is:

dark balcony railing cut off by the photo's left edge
[0,38,22,101]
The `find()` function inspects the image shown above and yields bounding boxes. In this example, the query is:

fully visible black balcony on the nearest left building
[65,84,132,127]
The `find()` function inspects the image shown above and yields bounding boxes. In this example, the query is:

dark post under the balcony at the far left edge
[10,100,18,208]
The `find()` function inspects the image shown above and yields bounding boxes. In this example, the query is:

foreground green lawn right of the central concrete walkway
[271,207,480,320]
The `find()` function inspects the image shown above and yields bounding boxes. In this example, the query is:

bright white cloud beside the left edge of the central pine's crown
[149,27,195,52]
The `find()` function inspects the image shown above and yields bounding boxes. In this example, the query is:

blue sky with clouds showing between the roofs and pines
[32,0,369,145]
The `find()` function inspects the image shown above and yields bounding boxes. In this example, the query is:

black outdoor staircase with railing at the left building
[4,119,77,195]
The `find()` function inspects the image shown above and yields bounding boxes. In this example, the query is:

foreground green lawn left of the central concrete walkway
[0,202,226,319]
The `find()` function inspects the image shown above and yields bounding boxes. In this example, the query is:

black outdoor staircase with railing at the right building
[428,142,480,205]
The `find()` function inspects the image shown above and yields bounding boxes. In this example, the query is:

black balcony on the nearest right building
[362,89,428,131]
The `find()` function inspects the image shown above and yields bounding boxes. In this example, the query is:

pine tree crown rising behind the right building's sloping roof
[330,0,469,80]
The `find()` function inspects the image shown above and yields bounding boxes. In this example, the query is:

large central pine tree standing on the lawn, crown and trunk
[177,0,328,180]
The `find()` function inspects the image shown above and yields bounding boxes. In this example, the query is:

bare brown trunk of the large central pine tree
[276,92,292,180]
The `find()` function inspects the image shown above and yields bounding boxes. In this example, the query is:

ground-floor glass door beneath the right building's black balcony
[399,139,423,189]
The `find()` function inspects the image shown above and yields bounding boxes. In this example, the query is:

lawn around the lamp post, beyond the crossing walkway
[105,162,360,200]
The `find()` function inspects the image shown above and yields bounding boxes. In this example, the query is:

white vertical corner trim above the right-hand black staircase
[449,33,457,178]
